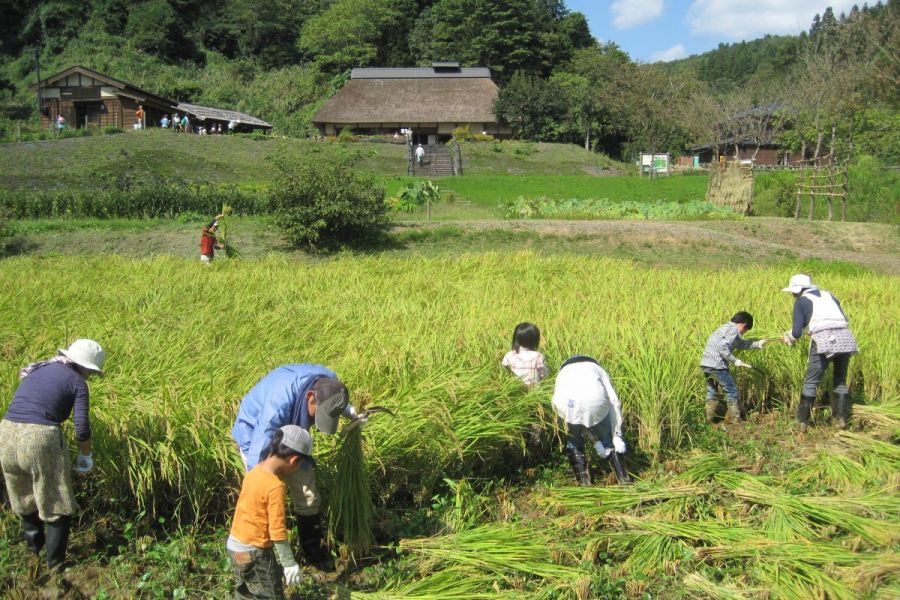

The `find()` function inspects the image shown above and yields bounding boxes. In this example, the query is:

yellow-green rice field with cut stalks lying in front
[0,253,900,600]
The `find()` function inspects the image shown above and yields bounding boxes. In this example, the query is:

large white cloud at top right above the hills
[687,0,861,40]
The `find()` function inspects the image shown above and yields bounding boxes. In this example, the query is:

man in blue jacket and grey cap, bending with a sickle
[231,364,366,570]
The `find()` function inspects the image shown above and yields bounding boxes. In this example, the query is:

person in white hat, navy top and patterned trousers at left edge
[0,339,106,571]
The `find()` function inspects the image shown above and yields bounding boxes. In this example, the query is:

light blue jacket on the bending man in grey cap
[231,364,337,471]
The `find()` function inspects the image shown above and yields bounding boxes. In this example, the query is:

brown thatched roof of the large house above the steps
[313,77,497,124]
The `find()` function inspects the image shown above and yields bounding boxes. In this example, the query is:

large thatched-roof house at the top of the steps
[313,62,510,143]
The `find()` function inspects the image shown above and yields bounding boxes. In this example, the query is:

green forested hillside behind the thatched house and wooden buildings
[0,0,900,164]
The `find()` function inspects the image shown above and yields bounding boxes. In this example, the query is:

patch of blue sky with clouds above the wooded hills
[566,0,874,62]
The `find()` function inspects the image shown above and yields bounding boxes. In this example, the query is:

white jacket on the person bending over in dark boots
[553,362,622,437]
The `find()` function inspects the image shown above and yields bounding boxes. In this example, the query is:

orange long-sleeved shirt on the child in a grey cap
[231,465,288,548]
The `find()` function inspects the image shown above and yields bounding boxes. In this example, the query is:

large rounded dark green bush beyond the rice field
[269,161,388,252]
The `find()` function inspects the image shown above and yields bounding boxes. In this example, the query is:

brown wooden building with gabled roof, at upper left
[32,65,174,129]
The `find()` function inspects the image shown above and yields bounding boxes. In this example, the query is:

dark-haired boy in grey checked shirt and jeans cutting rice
[700,310,768,423]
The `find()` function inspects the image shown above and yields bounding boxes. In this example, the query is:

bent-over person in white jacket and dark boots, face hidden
[552,356,631,486]
